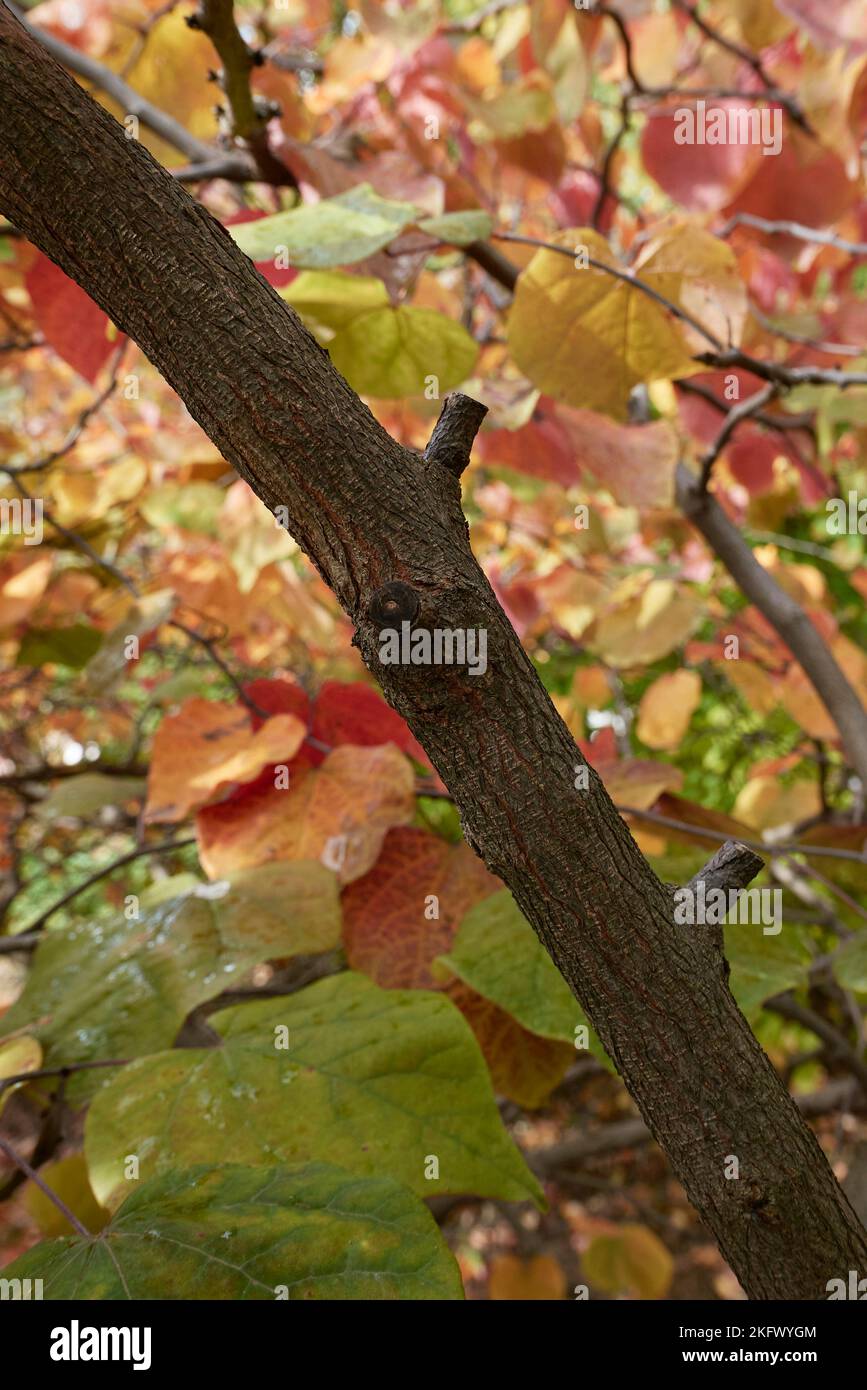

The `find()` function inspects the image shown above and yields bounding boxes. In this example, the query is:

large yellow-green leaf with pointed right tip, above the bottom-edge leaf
[85,973,540,1207]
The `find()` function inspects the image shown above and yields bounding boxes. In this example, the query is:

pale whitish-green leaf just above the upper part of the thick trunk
[226,183,418,270]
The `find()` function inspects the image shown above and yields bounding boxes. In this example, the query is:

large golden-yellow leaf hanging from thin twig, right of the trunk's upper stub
[509,228,696,420]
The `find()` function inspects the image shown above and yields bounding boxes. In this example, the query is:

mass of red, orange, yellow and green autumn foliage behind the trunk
[0,0,867,1300]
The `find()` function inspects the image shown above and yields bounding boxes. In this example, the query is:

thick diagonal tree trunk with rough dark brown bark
[0,4,867,1298]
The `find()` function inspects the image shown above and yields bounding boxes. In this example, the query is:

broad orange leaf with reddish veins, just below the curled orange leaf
[196,744,415,883]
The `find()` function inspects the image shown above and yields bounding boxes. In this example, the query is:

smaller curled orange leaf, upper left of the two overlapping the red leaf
[145,698,306,821]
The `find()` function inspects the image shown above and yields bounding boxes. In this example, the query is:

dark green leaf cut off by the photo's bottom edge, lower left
[3,1163,463,1301]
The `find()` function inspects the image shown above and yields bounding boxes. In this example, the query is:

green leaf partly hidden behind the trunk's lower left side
[439,888,610,1066]
